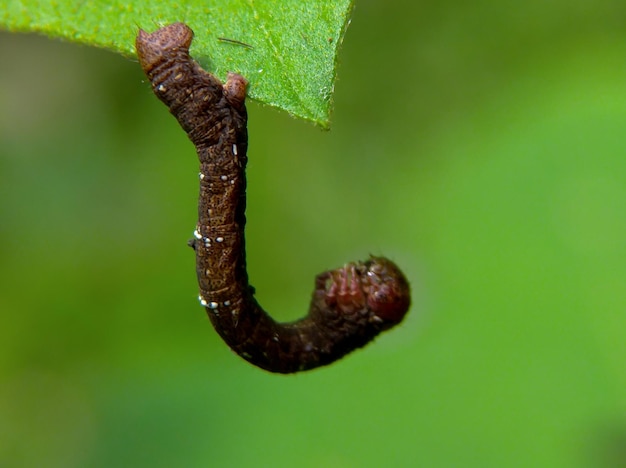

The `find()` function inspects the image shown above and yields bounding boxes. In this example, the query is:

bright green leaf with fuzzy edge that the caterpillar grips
[0,0,352,128]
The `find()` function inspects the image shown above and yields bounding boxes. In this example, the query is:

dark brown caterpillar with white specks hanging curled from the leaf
[136,23,410,373]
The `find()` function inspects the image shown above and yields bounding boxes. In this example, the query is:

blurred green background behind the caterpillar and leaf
[0,0,626,468]
